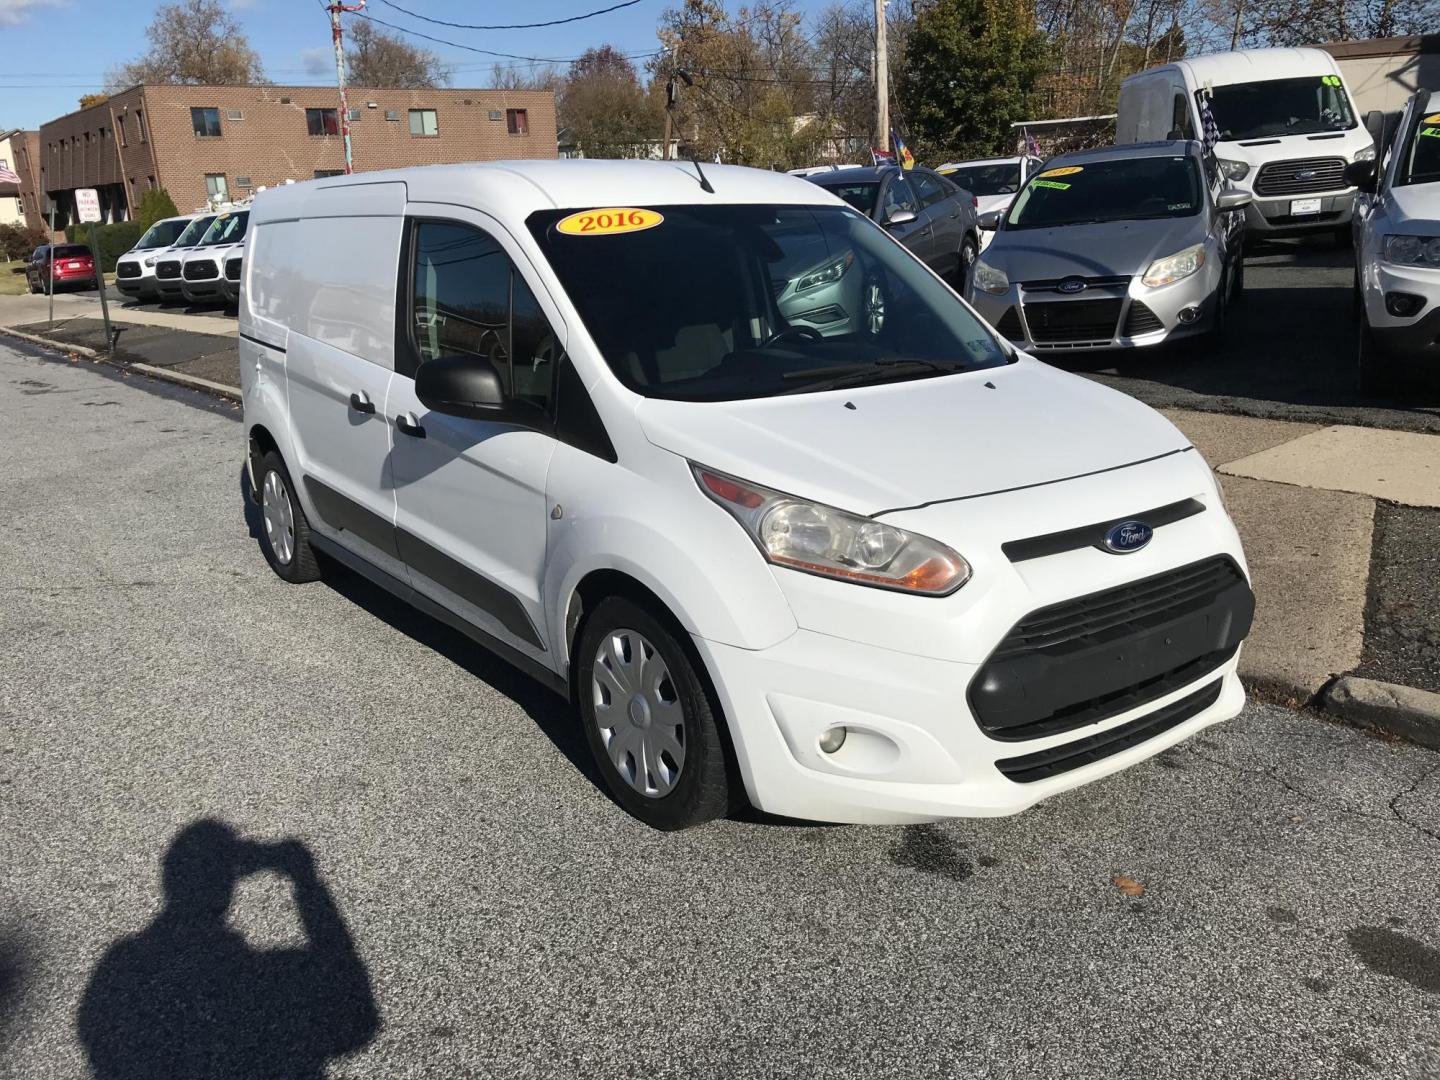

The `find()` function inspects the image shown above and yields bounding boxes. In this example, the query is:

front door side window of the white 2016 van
[409,222,559,409]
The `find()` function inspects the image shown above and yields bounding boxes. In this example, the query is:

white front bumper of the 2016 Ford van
[696,451,1253,824]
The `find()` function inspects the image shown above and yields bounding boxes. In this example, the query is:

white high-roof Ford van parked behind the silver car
[1115,49,1375,243]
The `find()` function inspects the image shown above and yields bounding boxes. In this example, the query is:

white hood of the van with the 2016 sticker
[636,356,1189,516]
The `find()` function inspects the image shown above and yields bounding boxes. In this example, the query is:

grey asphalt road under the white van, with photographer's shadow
[8,344,1440,1080]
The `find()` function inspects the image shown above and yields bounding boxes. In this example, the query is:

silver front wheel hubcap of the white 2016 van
[590,629,685,799]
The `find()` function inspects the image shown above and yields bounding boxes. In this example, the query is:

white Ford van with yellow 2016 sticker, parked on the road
[239,161,1253,828]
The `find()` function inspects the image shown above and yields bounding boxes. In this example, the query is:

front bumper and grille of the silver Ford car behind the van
[971,264,1220,356]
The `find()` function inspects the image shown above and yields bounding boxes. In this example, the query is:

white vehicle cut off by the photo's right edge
[1346,89,1440,392]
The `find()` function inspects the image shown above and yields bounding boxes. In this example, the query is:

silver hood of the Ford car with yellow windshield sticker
[984,213,1205,281]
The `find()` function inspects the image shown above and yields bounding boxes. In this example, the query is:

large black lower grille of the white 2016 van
[969,556,1254,740]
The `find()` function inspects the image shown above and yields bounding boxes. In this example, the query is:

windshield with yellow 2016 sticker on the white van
[527,203,1011,402]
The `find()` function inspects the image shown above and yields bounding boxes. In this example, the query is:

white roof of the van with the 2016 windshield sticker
[251,160,842,225]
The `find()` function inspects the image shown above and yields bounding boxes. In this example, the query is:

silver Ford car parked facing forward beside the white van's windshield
[968,141,1250,354]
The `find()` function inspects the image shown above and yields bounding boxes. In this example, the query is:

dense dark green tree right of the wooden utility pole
[897,0,1045,164]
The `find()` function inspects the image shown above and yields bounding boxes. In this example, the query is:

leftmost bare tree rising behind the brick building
[107,0,265,91]
